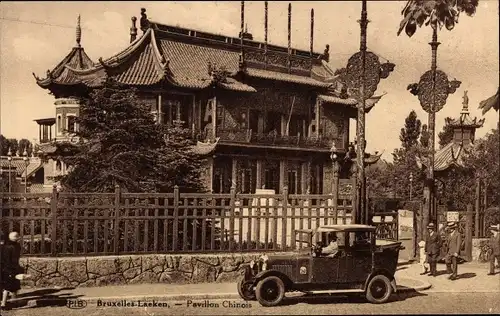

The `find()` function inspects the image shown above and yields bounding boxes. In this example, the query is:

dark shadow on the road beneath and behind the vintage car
[280,287,427,306]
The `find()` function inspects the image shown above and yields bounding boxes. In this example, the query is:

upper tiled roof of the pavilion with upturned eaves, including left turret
[32,22,333,92]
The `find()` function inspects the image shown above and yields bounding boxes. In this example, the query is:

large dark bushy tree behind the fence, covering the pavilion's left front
[53,79,203,192]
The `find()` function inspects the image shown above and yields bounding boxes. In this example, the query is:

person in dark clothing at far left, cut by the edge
[1,232,24,308]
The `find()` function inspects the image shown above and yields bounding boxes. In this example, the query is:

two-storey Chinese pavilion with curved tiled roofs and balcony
[35,4,381,194]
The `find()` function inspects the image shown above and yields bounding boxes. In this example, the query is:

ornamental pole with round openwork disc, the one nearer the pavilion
[340,0,395,223]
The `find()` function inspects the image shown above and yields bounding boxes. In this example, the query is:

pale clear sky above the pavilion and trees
[0,0,499,161]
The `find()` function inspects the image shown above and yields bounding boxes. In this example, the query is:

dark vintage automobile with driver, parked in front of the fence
[238,224,403,306]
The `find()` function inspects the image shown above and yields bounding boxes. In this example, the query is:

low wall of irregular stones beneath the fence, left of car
[21,253,274,288]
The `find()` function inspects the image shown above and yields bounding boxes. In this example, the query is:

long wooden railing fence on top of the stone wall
[0,187,352,256]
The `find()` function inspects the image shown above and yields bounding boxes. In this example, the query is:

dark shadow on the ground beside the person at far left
[6,288,83,310]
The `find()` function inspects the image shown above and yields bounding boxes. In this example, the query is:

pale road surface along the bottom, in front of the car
[2,293,500,316]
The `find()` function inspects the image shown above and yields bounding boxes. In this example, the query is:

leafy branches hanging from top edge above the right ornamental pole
[398,0,479,37]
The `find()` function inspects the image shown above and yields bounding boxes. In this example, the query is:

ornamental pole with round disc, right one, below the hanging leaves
[407,27,461,227]
